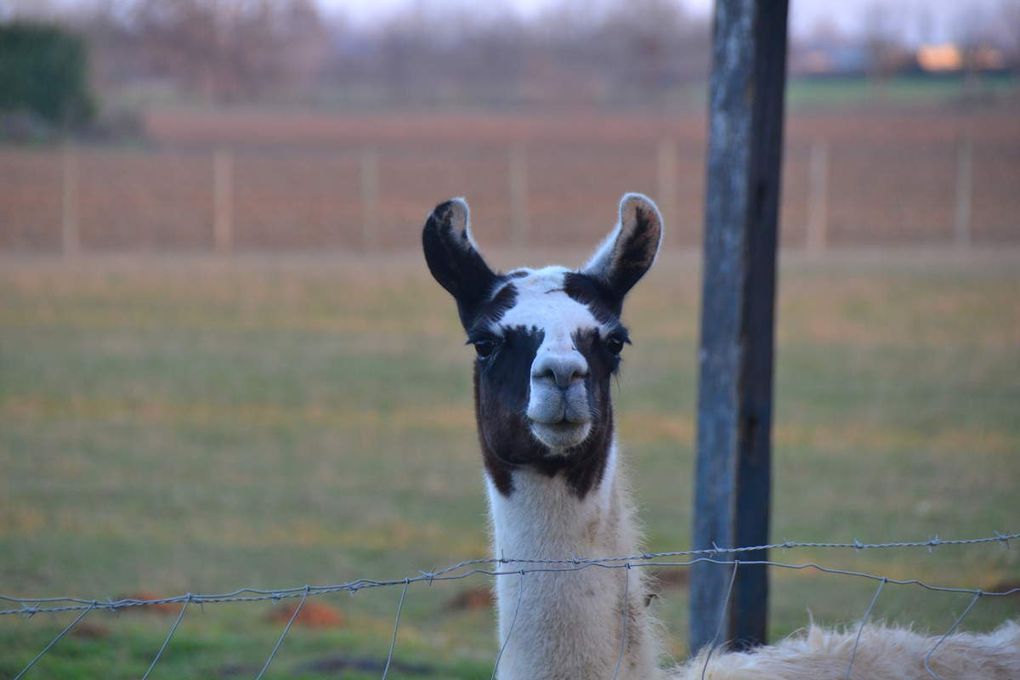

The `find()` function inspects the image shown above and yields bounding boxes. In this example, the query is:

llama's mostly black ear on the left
[421,199,496,328]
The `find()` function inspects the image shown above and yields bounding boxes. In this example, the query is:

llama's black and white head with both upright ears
[422,194,662,496]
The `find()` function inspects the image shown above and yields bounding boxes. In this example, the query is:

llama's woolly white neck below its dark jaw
[488,443,657,680]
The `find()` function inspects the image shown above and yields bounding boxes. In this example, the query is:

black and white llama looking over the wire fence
[422,194,1020,680]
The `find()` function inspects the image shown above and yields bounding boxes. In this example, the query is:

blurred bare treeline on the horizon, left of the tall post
[0,0,709,108]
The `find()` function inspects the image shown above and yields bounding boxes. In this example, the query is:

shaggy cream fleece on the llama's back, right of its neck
[670,622,1020,680]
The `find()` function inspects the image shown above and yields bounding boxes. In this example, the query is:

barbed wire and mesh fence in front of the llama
[0,532,1020,680]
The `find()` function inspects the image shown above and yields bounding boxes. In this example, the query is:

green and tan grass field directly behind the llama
[0,251,1020,679]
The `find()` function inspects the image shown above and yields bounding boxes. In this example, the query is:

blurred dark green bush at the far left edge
[0,21,96,125]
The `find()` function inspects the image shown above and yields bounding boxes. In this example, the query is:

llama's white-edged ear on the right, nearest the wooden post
[581,194,662,300]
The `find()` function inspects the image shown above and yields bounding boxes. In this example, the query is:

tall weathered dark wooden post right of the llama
[691,0,787,651]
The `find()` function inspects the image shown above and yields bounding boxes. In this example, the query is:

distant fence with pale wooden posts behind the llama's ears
[0,136,1020,255]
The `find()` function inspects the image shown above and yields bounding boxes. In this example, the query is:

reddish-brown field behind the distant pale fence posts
[0,110,1020,251]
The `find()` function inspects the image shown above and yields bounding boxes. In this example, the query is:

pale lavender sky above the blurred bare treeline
[318,0,1020,41]
